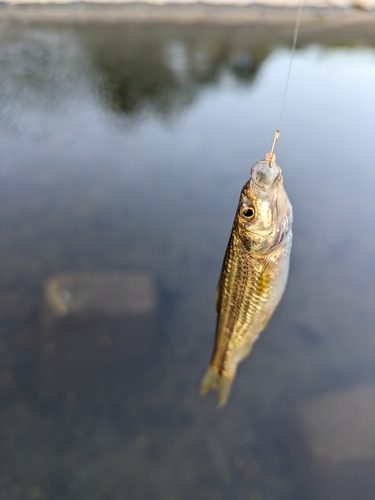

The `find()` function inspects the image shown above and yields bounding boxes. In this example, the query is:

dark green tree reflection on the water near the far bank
[90,26,268,114]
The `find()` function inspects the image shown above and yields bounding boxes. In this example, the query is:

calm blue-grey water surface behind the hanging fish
[0,13,375,500]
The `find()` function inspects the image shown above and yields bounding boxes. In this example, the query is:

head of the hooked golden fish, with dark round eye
[234,160,292,254]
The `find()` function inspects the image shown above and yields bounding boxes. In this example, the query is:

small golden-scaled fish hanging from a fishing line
[200,153,293,406]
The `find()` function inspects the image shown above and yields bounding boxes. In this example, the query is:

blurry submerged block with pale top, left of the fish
[40,272,157,398]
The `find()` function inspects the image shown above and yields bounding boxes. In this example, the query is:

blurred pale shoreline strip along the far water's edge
[0,1,375,23]
